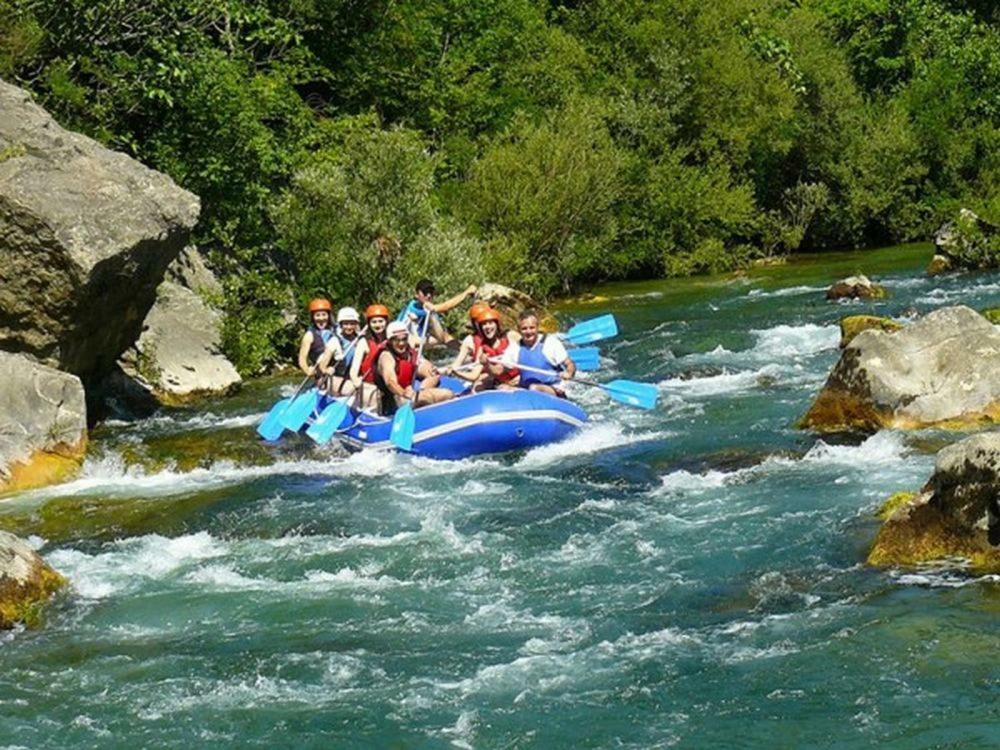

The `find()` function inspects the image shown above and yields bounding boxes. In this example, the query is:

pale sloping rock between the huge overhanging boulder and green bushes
[119,281,242,404]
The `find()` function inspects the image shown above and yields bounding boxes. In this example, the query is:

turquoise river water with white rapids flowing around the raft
[0,248,1000,748]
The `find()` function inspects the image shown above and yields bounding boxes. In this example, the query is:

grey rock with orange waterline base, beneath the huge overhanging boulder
[0,352,87,492]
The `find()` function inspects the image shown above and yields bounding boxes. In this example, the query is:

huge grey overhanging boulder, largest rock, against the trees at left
[0,81,199,382]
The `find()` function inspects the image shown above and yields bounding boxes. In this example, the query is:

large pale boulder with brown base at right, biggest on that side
[800,306,1000,431]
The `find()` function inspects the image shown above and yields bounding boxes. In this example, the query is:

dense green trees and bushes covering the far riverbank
[0,0,1000,372]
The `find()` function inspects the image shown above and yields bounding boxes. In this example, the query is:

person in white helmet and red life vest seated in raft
[375,320,455,415]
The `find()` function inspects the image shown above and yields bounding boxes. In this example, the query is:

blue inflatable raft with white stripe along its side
[338,378,587,459]
